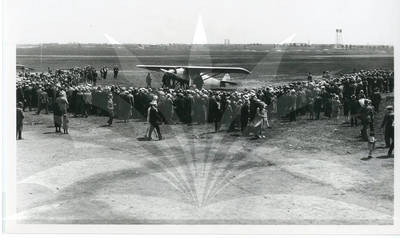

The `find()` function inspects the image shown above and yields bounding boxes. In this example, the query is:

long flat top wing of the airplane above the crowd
[136,65,250,74]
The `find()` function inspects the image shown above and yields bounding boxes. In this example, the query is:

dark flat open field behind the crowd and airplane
[17,43,393,87]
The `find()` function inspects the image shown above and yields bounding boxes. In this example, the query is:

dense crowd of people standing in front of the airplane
[17,66,394,154]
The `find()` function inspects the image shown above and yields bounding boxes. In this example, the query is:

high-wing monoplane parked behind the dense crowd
[136,65,250,88]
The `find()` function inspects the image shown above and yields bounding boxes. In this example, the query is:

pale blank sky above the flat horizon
[6,0,400,45]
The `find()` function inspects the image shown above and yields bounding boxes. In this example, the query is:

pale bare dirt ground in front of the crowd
[17,93,394,224]
